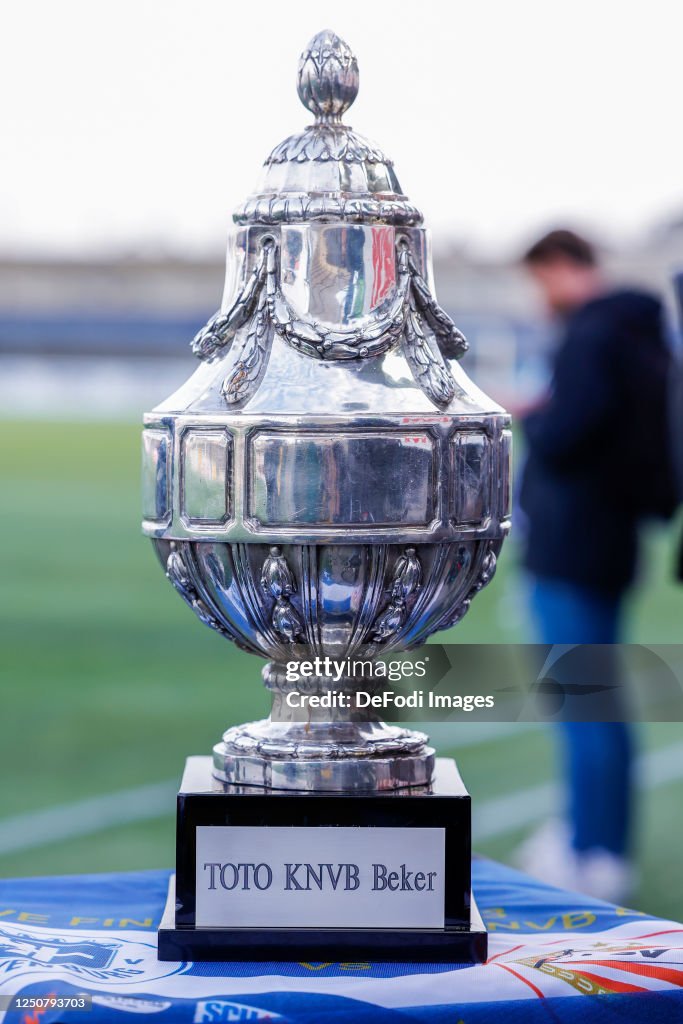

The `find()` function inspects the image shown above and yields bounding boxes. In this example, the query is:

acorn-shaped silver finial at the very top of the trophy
[297,29,358,124]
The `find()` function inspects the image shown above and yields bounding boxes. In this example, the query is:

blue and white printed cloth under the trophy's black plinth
[0,860,683,1024]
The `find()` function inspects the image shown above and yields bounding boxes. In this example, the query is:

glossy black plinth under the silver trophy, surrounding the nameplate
[159,757,487,963]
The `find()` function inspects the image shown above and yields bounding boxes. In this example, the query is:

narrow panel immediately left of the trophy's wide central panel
[180,428,232,526]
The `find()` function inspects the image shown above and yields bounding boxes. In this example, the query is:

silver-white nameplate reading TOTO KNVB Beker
[196,825,445,928]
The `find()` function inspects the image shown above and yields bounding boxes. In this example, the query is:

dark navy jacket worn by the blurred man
[520,291,675,594]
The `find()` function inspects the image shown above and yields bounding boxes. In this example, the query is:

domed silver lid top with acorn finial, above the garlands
[233,29,422,226]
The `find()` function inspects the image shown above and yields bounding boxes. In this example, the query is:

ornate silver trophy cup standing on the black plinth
[143,31,511,948]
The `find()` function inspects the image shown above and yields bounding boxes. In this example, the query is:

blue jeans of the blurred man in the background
[530,577,633,856]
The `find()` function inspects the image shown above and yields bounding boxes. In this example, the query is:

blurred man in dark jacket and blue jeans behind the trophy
[520,230,675,901]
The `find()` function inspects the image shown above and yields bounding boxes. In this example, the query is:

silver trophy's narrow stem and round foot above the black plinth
[213,662,434,793]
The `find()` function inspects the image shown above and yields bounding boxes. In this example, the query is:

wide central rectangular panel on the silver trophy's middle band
[249,431,436,529]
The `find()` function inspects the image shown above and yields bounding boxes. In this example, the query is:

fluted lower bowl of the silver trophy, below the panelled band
[153,540,501,663]
